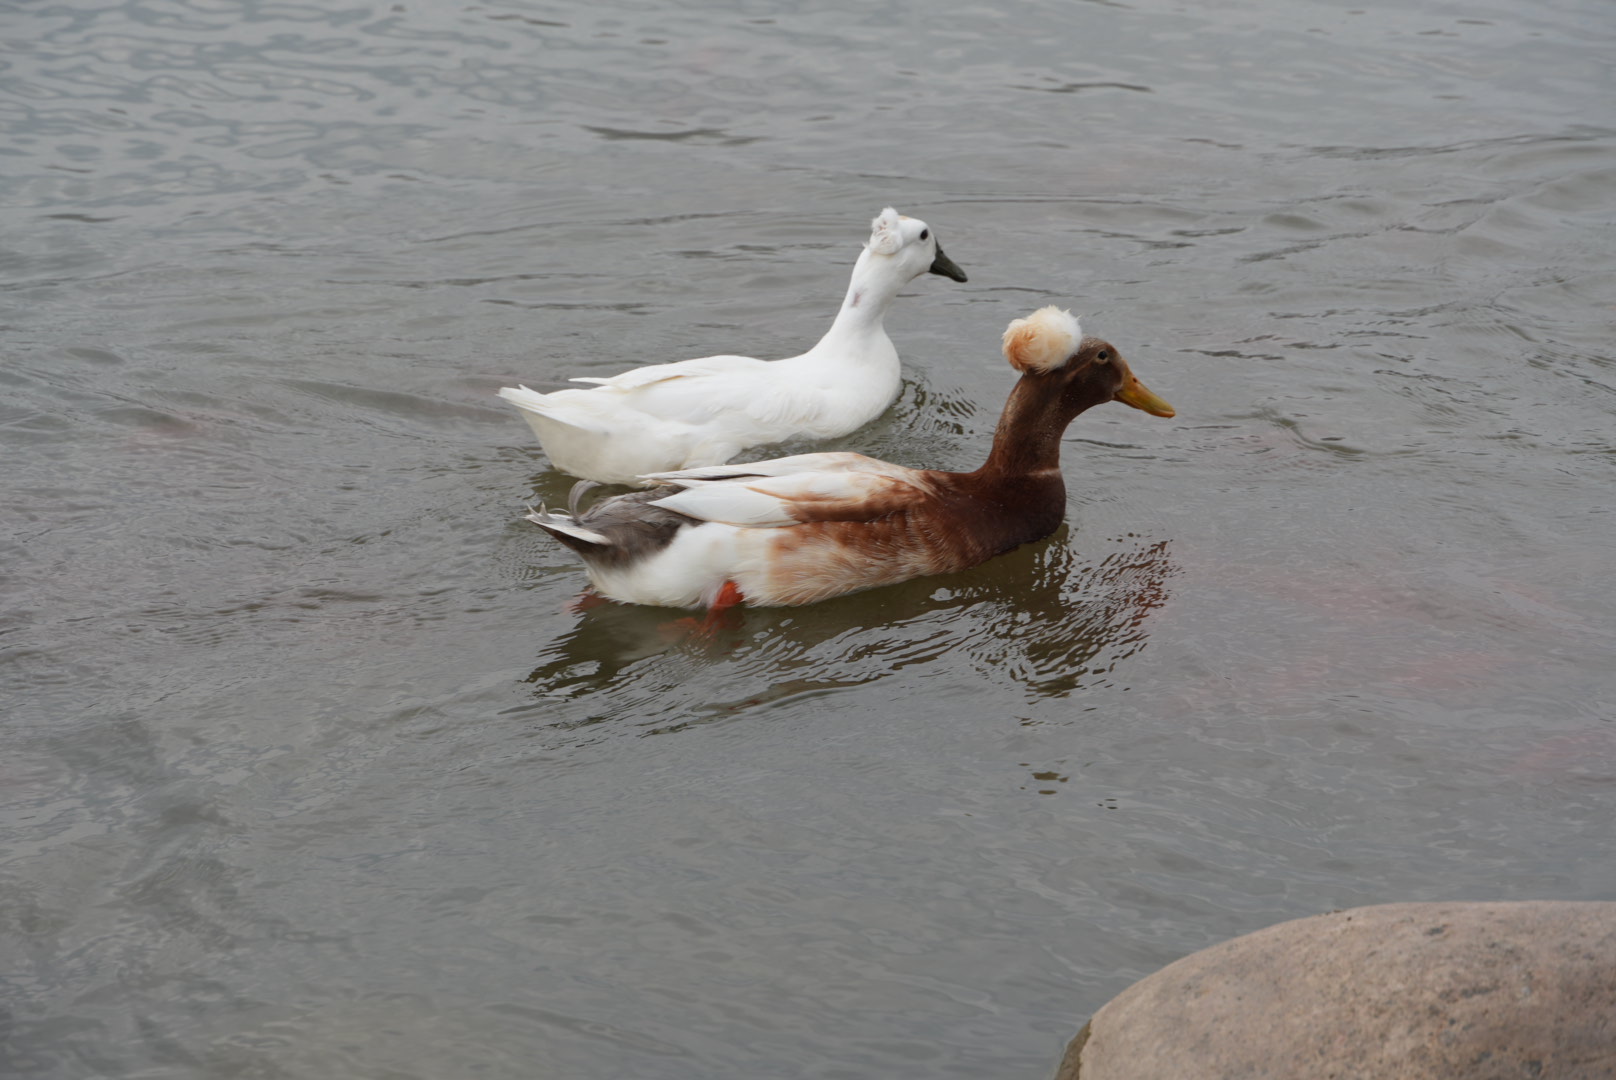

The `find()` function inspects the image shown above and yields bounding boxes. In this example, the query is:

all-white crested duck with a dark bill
[499,207,965,483]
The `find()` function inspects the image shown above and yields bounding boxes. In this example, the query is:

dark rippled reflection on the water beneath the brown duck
[527,527,1176,717]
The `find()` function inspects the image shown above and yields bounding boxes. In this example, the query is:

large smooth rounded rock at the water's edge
[1055,902,1616,1080]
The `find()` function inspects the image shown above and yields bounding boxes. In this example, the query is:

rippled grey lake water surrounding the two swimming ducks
[0,0,1616,1080]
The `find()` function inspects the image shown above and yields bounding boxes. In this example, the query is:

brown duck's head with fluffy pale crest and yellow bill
[1004,307,1175,419]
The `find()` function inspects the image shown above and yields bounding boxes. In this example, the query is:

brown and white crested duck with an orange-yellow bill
[527,307,1173,611]
